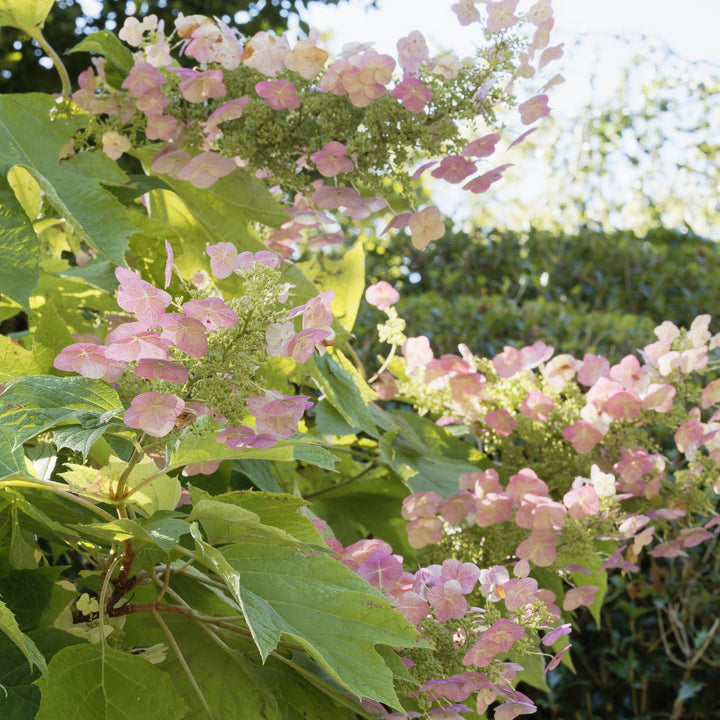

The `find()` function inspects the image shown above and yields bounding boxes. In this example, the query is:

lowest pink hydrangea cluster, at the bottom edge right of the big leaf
[327,528,570,720]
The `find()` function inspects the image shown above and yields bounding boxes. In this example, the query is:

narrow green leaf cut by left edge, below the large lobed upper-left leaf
[0,176,40,311]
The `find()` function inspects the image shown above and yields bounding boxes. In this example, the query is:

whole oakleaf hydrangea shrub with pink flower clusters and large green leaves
[0,0,718,720]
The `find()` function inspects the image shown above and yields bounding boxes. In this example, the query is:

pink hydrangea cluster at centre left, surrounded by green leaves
[54,242,334,448]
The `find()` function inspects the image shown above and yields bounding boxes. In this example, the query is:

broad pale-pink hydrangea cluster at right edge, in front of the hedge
[368,287,720,632]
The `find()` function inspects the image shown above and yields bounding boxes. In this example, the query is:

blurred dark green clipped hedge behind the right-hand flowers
[356,228,720,359]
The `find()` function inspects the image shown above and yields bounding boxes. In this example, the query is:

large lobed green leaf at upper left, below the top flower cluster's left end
[0,93,135,265]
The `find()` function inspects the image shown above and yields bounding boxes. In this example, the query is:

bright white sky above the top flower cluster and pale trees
[306,0,720,239]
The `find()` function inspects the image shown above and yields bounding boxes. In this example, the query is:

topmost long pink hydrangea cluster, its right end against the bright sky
[63,0,562,256]
